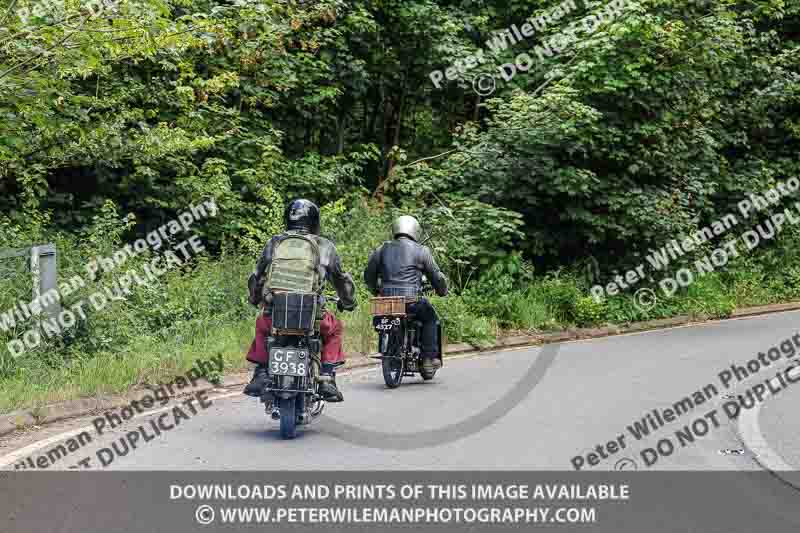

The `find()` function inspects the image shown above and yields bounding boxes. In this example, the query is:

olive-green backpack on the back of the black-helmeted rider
[264,233,323,296]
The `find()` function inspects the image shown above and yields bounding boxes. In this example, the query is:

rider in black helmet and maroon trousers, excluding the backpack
[244,199,356,402]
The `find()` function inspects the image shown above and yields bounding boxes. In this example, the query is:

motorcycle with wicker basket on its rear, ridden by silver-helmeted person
[370,278,443,389]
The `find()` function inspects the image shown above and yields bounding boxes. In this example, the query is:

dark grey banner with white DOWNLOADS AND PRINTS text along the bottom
[0,471,800,533]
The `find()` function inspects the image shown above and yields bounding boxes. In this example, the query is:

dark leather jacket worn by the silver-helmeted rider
[364,236,447,296]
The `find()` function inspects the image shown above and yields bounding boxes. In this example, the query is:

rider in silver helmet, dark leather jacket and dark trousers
[364,215,447,372]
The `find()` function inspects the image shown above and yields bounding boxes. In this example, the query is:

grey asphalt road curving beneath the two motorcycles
[0,312,800,470]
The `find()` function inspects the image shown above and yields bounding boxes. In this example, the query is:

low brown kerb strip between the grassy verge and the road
[0,302,800,437]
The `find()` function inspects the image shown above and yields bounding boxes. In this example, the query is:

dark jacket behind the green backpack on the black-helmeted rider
[247,231,356,311]
